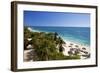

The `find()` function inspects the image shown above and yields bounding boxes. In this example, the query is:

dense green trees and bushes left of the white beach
[24,27,80,61]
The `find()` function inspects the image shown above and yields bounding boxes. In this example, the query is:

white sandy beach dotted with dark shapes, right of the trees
[62,40,90,59]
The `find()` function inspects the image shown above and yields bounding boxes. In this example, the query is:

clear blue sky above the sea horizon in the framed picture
[24,11,90,27]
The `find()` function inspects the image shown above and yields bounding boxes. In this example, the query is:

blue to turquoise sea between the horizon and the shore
[29,26,90,46]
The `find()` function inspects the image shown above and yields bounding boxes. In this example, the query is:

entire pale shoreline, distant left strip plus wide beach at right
[28,27,90,59]
